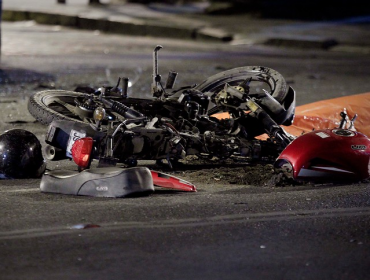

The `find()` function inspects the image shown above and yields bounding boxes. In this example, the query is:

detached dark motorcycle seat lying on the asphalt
[40,167,154,197]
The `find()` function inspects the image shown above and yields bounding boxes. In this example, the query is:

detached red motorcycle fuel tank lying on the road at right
[275,129,370,180]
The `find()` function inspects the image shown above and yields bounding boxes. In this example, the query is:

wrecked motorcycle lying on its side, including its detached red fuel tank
[28,46,370,195]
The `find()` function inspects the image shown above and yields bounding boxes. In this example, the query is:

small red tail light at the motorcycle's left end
[72,137,94,169]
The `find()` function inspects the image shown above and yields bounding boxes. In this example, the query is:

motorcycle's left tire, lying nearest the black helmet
[28,90,86,125]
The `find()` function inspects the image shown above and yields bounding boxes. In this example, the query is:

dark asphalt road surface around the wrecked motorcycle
[0,22,370,280]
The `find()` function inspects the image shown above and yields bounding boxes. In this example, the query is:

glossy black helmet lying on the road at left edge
[0,129,45,178]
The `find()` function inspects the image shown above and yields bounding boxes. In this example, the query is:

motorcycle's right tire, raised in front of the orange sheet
[195,66,289,103]
